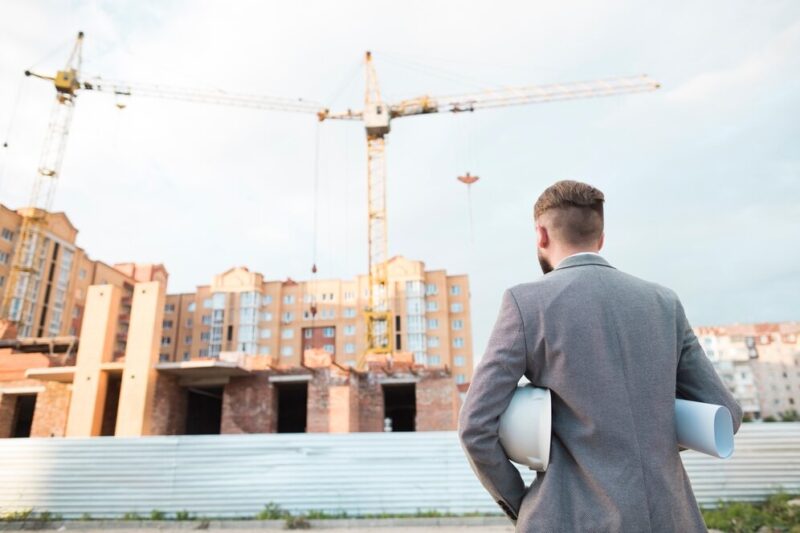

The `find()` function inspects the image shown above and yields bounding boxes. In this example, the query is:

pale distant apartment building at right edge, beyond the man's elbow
[694,322,800,419]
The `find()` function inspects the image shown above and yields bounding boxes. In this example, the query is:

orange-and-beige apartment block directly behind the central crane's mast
[160,256,472,384]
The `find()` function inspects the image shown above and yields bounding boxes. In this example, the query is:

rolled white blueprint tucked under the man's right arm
[675,400,733,459]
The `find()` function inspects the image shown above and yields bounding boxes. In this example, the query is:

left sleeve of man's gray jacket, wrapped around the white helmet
[458,290,526,523]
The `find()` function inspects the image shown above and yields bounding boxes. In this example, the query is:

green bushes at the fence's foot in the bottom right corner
[703,492,800,533]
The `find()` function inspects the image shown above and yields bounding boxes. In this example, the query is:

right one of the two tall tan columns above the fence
[114,281,165,437]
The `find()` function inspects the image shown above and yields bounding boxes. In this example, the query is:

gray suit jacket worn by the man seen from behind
[458,255,742,533]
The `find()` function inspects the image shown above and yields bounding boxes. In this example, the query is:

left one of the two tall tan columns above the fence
[66,285,122,437]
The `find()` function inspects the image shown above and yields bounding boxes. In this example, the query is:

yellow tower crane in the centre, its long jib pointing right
[319,52,659,368]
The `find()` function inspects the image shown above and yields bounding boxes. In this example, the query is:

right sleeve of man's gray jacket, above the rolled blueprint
[675,300,742,433]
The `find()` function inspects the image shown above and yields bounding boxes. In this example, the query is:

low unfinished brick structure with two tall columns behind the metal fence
[0,281,460,437]
